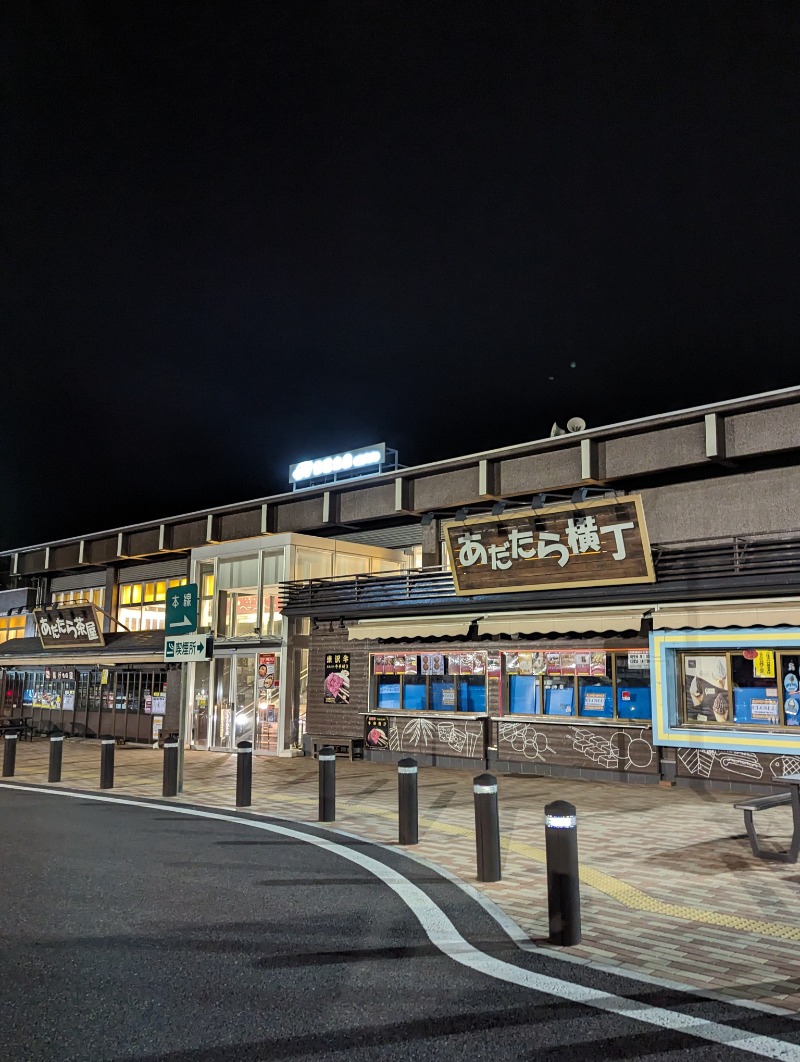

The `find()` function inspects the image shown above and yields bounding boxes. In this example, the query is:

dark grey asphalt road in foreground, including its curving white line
[0,788,800,1062]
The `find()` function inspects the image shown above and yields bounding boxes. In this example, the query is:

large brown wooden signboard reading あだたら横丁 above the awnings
[444,495,656,594]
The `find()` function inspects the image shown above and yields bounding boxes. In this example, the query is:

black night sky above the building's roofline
[0,6,800,548]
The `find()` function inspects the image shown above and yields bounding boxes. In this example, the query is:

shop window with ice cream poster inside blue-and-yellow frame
[679,648,800,726]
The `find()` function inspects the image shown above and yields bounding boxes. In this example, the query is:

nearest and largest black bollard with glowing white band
[544,800,580,947]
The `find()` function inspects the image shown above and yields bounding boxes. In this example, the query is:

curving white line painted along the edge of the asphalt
[6,783,800,1062]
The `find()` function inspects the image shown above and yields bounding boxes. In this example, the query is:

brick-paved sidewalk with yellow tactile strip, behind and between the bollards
[3,740,800,1012]
